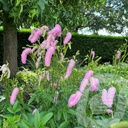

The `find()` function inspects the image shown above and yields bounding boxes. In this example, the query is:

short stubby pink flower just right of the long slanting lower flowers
[90,77,99,92]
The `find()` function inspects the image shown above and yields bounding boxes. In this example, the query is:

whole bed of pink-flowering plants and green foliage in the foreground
[0,24,128,128]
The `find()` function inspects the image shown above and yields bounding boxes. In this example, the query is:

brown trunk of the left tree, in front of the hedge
[3,18,18,76]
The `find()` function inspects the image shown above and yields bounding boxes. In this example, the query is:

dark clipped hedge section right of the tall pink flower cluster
[68,34,128,62]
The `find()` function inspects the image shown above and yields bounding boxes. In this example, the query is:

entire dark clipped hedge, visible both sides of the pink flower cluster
[0,31,128,66]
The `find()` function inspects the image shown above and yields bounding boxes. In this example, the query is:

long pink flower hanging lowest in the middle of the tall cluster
[44,46,55,67]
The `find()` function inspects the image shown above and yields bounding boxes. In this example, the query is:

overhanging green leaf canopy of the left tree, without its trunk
[0,0,104,30]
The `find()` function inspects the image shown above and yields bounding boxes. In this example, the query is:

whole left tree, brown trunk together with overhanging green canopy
[0,0,104,75]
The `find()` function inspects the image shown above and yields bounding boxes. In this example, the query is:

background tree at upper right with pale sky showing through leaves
[85,0,128,34]
